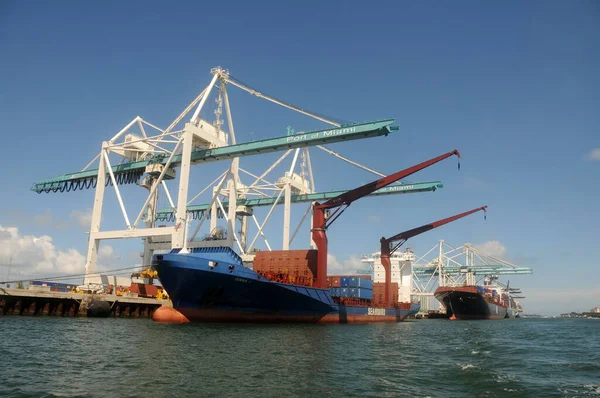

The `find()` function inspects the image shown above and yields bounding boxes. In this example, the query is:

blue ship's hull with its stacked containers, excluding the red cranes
[154,247,420,323]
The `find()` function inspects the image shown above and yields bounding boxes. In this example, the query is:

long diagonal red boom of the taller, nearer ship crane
[315,149,460,210]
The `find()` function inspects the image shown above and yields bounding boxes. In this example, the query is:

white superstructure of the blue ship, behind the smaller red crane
[361,249,415,302]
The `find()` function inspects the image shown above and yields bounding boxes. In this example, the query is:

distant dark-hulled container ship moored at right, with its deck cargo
[434,284,523,319]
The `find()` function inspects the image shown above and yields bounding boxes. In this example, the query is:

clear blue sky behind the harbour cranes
[0,1,600,313]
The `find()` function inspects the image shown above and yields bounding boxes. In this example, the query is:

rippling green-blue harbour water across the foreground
[0,316,600,398]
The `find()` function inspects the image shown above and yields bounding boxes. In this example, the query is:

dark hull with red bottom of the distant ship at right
[434,286,518,320]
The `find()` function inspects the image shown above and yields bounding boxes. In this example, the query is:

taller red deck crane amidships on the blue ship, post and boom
[311,149,460,289]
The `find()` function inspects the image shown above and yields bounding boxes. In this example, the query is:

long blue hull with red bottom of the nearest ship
[154,253,420,323]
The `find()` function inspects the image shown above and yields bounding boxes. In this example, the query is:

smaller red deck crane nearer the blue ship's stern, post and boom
[380,206,487,306]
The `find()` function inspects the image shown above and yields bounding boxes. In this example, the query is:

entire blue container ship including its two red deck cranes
[152,150,487,323]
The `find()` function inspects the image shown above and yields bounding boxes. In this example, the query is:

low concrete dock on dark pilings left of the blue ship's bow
[0,288,166,318]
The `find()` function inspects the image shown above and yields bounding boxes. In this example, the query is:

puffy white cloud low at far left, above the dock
[0,225,85,276]
